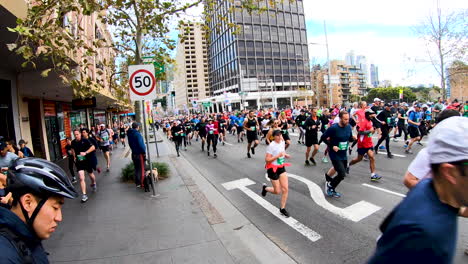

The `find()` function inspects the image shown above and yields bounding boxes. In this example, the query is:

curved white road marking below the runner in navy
[288,173,382,222]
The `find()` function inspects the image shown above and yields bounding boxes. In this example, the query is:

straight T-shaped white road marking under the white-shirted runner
[222,178,322,242]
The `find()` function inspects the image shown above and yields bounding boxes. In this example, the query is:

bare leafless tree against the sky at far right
[414,6,468,99]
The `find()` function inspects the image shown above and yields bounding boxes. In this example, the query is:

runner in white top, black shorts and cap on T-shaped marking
[262,130,291,217]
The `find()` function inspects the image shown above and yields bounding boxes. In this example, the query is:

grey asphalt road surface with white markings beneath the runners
[171,130,468,263]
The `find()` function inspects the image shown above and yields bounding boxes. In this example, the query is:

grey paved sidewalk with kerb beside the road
[44,134,294,263]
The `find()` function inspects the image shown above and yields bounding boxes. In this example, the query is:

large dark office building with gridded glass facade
[208,0,311,96]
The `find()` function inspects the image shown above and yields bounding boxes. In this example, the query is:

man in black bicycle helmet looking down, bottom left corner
[0,158,78,263]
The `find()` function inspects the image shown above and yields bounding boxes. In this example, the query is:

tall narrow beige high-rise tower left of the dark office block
[174,23,210,109]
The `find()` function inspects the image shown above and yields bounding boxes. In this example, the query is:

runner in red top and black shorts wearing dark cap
[346,109,382,181]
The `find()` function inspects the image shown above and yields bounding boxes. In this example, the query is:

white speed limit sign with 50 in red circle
[128,64,157,101]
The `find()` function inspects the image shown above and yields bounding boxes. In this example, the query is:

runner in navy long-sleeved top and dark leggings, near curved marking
[322,111,356,198]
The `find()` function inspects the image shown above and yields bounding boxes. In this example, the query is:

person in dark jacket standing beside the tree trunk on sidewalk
[127,122,146,188]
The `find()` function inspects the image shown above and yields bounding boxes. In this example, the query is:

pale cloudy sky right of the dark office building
[175,0,468,86]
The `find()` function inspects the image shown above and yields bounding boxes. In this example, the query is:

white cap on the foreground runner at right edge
[427,116,468,164]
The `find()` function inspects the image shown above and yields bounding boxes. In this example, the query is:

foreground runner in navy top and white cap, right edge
[368,117,468,264]
